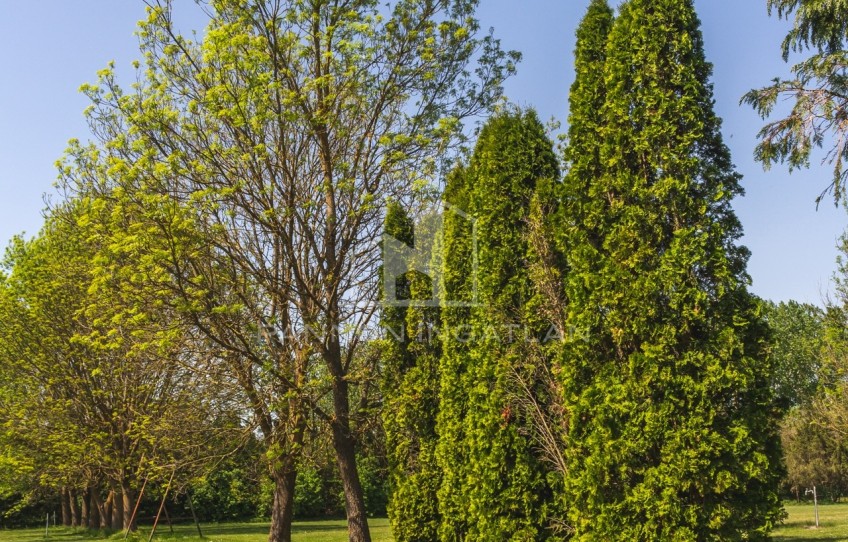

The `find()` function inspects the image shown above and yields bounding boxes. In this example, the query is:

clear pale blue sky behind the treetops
[0,0,846,304]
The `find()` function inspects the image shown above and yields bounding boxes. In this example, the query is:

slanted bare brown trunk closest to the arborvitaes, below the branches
[327,341,371,542]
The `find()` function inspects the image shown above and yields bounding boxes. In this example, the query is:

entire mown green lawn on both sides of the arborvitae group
[0,504,848,542]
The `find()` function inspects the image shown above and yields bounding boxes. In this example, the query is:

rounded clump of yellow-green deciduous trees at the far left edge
[0,204,222,527]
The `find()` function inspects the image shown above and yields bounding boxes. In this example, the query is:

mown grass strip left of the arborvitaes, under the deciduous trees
[0,519,392,542]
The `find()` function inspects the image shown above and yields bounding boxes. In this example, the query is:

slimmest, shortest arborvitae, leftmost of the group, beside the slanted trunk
[383,203,441,542]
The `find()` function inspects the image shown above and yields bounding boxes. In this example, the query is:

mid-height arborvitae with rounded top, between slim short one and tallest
[439,111,558,541]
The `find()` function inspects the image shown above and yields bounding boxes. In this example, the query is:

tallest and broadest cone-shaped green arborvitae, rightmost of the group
[561,0,781,540]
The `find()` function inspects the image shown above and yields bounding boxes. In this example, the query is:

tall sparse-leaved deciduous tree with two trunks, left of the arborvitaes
[61,0,516,541]
